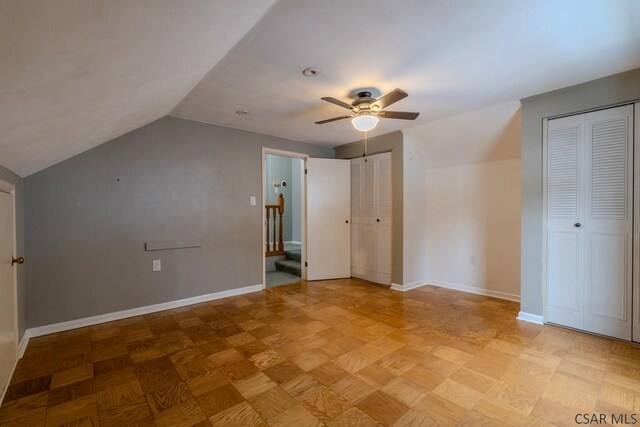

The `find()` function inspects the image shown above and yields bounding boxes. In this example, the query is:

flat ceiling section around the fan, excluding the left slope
[171,0,640,146]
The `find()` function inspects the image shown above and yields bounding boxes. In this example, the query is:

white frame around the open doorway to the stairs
[260,147,309,289]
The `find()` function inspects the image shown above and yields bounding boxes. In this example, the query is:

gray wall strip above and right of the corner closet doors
[335,131,404,284]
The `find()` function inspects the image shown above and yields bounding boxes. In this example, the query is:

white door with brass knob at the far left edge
[0,189,18,399]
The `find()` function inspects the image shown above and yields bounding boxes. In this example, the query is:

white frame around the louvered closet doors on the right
[541,101,640,342]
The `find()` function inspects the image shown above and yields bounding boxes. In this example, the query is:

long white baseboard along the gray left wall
[18,285,265,358]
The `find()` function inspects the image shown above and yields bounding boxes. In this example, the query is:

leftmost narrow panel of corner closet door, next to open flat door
[351,158,364,277]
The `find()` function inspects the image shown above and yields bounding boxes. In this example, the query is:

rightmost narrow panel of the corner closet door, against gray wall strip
[373,153,393,284]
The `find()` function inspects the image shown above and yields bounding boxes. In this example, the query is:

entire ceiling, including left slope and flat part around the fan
[0,0,640,176]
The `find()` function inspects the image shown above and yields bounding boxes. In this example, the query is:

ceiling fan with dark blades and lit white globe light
[316,89,420,132]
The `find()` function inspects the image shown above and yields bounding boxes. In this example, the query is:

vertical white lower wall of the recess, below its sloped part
[426,159,520,299]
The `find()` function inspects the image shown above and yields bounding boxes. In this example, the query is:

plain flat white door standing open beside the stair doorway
[307,158,351,280]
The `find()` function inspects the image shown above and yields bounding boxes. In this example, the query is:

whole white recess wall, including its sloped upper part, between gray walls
[403,101,520,299]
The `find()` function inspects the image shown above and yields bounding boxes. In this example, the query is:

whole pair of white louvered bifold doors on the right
[546,106,633,340]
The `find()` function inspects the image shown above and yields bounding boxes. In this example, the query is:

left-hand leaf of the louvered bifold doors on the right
[546,116,585,329]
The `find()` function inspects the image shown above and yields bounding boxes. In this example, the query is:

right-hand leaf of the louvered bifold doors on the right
[581,105,633,340]
